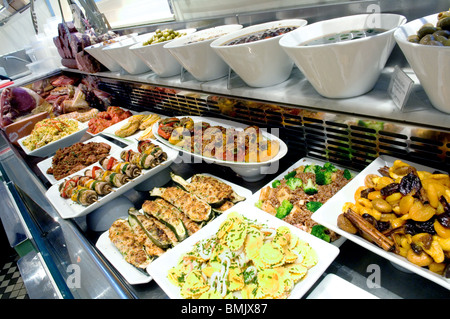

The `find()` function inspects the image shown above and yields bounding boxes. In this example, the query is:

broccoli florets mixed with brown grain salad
[255,162,353,242]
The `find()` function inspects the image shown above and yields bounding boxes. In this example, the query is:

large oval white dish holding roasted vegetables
[153,116,287,182]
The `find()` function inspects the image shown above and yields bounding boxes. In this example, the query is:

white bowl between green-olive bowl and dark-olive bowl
[164,24,242,81]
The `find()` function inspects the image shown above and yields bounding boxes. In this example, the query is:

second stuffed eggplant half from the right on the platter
[150,187,213,222]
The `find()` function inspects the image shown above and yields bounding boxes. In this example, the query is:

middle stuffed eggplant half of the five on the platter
[142,200,188,241]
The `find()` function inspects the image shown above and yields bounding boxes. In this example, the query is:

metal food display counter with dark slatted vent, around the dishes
[0,1,450,299]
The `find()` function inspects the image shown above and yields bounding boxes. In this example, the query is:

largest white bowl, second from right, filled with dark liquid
[280,13,406,98]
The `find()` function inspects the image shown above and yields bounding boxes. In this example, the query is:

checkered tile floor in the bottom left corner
[0,256,29,299]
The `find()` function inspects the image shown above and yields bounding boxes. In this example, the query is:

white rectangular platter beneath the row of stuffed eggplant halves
[95,173,252,285]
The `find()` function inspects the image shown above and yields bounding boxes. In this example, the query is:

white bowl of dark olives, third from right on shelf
[211,19,307,87]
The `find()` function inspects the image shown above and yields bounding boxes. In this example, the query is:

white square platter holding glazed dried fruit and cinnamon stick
[312,155,450,289]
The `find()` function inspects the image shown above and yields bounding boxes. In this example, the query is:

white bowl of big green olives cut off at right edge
[394,13,450,113]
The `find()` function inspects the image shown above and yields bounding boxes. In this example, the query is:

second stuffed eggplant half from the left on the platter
[128,207,172,249]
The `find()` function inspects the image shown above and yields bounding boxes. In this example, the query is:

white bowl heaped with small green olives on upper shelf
[130,29,197,77]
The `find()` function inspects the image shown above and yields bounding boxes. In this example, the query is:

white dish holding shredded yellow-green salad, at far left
[17,120,88,157]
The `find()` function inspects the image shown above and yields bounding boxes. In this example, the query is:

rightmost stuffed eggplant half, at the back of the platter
[171,172,245,207]
